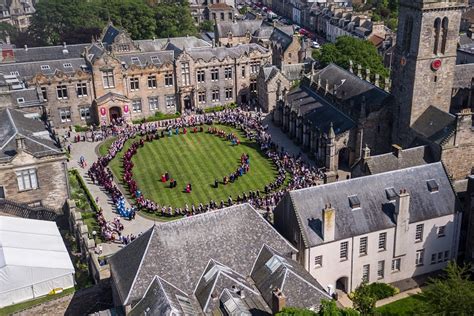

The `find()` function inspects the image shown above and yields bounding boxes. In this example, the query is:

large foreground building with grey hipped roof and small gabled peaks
[109,204,330,316]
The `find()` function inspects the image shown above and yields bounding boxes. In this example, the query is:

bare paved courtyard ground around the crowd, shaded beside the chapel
[65,115,314,255]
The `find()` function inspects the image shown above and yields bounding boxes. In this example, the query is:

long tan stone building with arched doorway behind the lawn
[0,25,271,127]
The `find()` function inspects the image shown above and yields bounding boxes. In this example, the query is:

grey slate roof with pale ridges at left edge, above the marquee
[0,108,63,162]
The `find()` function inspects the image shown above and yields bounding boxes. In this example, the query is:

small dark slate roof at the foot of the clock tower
[412,106,456,143]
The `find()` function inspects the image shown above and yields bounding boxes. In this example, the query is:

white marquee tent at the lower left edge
[0,216,74,307]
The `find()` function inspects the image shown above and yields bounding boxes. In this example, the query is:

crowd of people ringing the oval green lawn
[88,109,324,221]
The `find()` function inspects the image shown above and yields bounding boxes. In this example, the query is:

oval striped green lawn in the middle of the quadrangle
[99,126,277,211]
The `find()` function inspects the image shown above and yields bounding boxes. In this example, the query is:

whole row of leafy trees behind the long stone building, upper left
[28,0,196,45]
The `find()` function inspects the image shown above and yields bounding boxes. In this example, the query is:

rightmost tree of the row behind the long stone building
[154,0,197,38]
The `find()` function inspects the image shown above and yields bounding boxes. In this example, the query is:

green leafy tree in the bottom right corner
[419,262,474,315]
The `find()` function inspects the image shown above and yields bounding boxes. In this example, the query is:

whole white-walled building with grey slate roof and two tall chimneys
[274,162,462,293]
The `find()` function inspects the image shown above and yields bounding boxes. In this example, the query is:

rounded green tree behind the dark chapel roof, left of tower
[313,36,389,82]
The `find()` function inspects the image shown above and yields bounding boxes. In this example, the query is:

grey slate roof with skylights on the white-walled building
[282,162,460,247]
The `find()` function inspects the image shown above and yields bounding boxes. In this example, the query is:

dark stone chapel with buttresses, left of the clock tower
[273,64,391,180]
